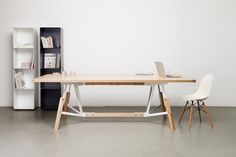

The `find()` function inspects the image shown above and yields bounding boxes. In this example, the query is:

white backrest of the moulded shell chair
[196,74,213,99]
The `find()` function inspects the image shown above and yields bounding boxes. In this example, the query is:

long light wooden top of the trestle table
[33,74,196,84]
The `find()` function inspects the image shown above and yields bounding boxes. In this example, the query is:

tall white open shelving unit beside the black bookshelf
[13,27,37,110]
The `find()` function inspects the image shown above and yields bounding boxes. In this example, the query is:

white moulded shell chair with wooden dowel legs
[179,74,213,128]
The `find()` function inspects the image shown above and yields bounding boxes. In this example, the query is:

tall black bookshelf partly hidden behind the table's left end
[39,27,63,110]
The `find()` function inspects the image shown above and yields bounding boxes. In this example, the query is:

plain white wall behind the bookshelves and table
[0,0,236,106]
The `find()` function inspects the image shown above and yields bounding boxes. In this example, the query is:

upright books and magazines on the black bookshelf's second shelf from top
[44,53,61,69]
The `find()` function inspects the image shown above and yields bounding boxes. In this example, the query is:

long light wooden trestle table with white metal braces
[34,74,195,130]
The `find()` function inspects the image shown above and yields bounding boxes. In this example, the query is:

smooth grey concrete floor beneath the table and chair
[0,107,236,157]
